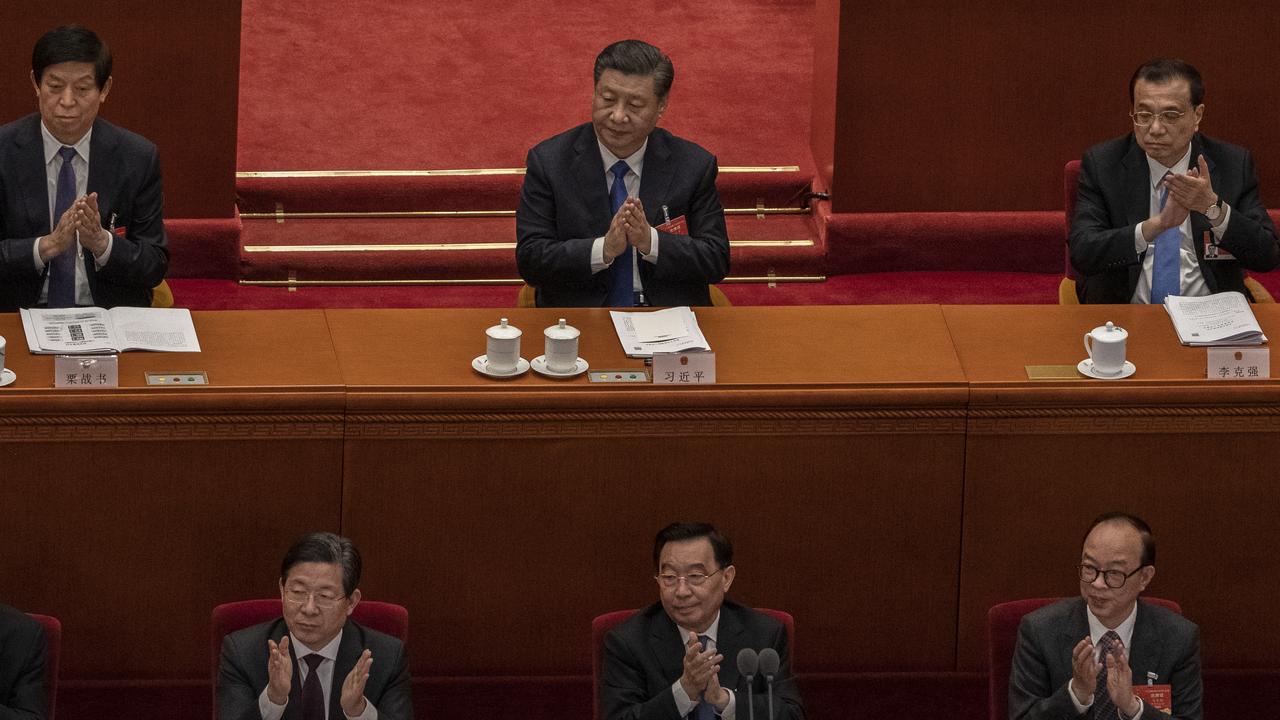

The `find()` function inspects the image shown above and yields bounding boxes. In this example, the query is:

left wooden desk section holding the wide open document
[0,311,344,680]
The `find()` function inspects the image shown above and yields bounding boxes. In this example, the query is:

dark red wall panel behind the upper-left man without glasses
[0,0,241,218]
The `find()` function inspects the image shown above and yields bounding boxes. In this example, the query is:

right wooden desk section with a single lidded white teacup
[943,305,1280,670]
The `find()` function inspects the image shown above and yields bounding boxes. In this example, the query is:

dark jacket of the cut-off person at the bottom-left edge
[0,605,47,720]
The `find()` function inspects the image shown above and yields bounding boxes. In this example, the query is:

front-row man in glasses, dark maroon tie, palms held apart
[218,533,413,720]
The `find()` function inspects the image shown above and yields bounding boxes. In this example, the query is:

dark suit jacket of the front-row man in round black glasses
[1009,597,1202,720]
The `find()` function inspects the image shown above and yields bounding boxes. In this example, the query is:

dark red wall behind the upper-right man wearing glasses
[812,0,1280,213]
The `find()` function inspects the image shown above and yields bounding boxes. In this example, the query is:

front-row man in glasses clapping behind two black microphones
[599,523,804,720]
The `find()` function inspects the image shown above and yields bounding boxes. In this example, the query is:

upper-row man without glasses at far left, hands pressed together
[0,26,169,311]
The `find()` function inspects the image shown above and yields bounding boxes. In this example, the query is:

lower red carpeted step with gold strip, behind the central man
[241,215,824,282]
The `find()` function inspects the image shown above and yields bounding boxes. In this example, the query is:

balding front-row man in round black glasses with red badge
[1009,512,1202,720]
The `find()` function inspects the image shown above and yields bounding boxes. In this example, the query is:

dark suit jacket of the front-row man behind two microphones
[600,600,804,720]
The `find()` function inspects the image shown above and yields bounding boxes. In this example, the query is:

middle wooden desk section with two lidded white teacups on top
[326,306,966,675]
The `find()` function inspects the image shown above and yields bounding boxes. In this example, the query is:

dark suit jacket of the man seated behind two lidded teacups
[516,123,728,307]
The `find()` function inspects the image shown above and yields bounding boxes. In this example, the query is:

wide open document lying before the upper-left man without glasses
[20,307,200,355]
